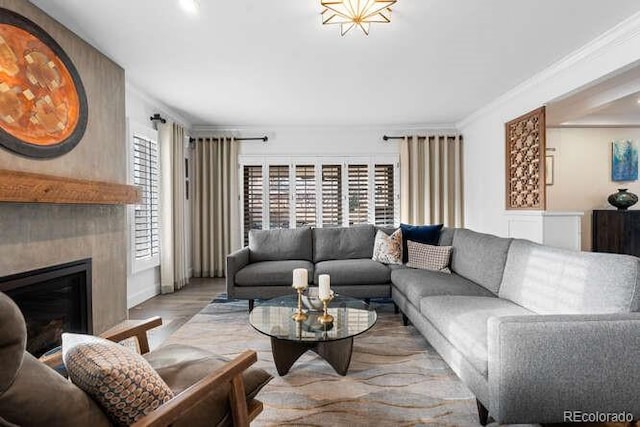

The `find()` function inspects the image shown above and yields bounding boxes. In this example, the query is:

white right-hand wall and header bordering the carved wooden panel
[458,15,640,236]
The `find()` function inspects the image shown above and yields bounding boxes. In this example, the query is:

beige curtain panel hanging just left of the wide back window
[192,137,240,277]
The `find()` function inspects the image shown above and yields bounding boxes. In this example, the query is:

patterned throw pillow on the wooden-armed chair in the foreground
[62,334,173,426]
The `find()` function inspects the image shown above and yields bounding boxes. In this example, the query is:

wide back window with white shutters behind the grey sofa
[240,156,398,239]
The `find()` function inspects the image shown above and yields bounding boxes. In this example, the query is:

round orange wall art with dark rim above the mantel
[0,8,88,158]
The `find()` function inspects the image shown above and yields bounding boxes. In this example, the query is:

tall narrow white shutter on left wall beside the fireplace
[133,135,160,260]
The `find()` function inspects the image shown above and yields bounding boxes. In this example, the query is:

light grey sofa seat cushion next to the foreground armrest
[420,296,535,377]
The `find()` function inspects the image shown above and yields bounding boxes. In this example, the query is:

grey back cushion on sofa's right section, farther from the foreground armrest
[451,228,513,295]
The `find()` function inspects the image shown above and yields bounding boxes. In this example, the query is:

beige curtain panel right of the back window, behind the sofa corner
[400,135,464,227]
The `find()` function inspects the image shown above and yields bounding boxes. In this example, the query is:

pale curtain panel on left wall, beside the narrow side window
[159,123,189,294]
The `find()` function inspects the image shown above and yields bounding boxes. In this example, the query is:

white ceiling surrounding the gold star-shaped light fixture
[31,0,640,127]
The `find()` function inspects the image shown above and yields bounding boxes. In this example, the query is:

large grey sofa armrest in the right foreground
[487,313,640,423]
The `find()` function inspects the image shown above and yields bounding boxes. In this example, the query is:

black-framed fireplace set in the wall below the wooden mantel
[0,259,93,357]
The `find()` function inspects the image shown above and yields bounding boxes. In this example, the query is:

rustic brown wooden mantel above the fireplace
[0,169,142,205]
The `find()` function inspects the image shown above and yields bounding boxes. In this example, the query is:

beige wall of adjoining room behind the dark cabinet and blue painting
[547,128,640,251]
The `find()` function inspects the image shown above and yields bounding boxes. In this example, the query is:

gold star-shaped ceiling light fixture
[320,0,397,36]
